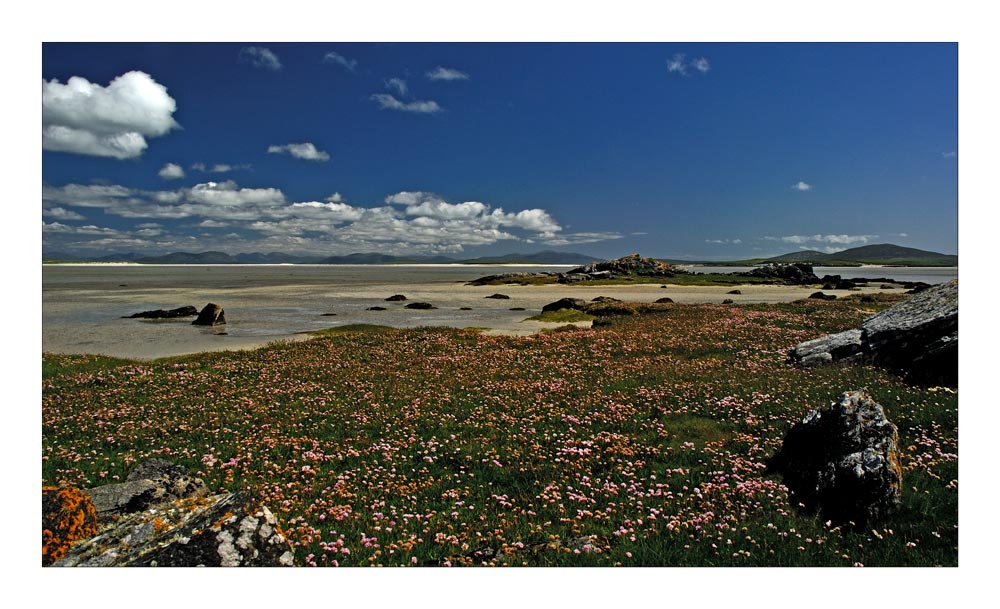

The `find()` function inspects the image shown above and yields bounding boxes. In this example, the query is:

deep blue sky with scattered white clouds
[42,42,958,260]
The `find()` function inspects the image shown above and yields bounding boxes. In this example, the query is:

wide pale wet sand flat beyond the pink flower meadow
[42,281,903,360]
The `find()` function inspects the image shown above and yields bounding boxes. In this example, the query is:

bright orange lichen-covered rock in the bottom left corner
[42,487,97,567]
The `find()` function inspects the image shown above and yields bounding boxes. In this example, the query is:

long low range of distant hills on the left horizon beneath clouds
[42,250,600,265]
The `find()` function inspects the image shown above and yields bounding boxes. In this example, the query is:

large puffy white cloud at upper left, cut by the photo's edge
[42,71,179,159]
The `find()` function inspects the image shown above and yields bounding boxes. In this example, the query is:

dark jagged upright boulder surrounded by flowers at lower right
[768,390,903,527]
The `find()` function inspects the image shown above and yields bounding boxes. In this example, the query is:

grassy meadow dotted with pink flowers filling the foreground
[42,298,958,566]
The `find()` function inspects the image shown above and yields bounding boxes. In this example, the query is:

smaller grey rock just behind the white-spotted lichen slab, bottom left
[83,459,208,523]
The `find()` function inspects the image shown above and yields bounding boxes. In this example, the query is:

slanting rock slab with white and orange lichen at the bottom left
[53,492,294,567]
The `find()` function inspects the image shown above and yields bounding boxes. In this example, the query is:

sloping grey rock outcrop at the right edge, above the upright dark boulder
[788,279,958,386]
